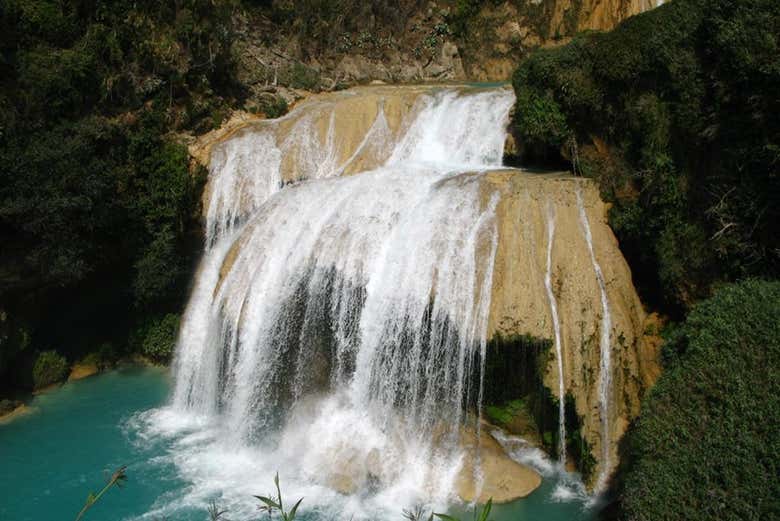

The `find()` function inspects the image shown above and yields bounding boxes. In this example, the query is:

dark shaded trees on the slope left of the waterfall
[0,0,240,385]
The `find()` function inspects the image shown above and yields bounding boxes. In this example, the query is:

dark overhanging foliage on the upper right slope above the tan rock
[513,0,780,316]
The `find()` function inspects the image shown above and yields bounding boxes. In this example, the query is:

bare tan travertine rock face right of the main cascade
[486,170,660,484]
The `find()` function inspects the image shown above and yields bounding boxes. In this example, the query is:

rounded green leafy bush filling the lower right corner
[622,280,780,521]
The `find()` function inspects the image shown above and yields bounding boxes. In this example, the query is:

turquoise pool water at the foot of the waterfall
[0,367,592,521]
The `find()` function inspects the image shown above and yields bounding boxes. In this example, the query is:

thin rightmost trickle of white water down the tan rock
[577,187,612,492]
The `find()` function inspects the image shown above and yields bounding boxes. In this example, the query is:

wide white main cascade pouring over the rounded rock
[162,89,514,509]
